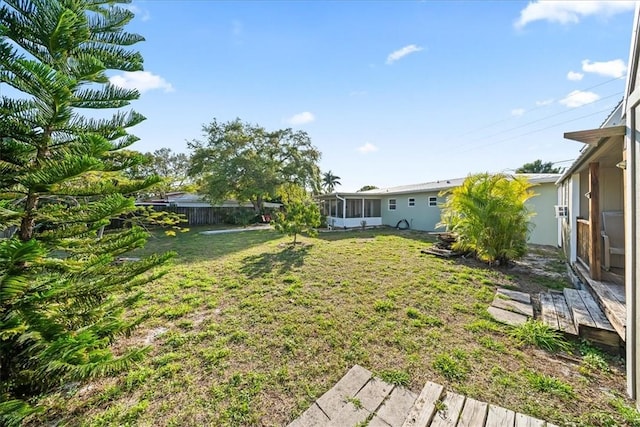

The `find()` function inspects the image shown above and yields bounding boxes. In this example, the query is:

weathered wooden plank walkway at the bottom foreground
[289,365,555,427]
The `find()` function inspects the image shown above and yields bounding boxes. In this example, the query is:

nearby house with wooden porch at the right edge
[558,6,640,407]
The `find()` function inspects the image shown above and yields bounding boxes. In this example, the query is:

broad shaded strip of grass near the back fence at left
[132,227,282,263]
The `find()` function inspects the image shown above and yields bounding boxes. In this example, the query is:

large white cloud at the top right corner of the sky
[514,0,635,28]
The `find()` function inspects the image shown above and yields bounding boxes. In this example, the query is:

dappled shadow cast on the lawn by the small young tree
[240,244,313,278]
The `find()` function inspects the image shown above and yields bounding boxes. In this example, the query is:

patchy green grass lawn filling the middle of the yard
[35,226,640,426]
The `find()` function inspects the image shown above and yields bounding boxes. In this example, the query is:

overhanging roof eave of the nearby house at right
[557,101,626,183]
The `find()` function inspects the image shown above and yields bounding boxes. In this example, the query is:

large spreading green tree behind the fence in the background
[188,119,321,211]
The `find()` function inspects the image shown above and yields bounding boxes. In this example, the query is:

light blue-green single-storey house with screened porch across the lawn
[318,174,560,245]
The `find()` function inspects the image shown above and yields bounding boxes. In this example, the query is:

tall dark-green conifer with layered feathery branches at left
[0,0,170,425]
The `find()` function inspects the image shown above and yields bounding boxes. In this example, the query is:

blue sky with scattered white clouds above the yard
[112,0,633,191]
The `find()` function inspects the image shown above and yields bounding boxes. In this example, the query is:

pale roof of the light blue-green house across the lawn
[320,173,560,198]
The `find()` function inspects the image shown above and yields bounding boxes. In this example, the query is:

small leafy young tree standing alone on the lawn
[273,184,321,245]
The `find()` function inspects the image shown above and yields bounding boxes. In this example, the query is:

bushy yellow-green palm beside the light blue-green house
[438,173,535,264]
